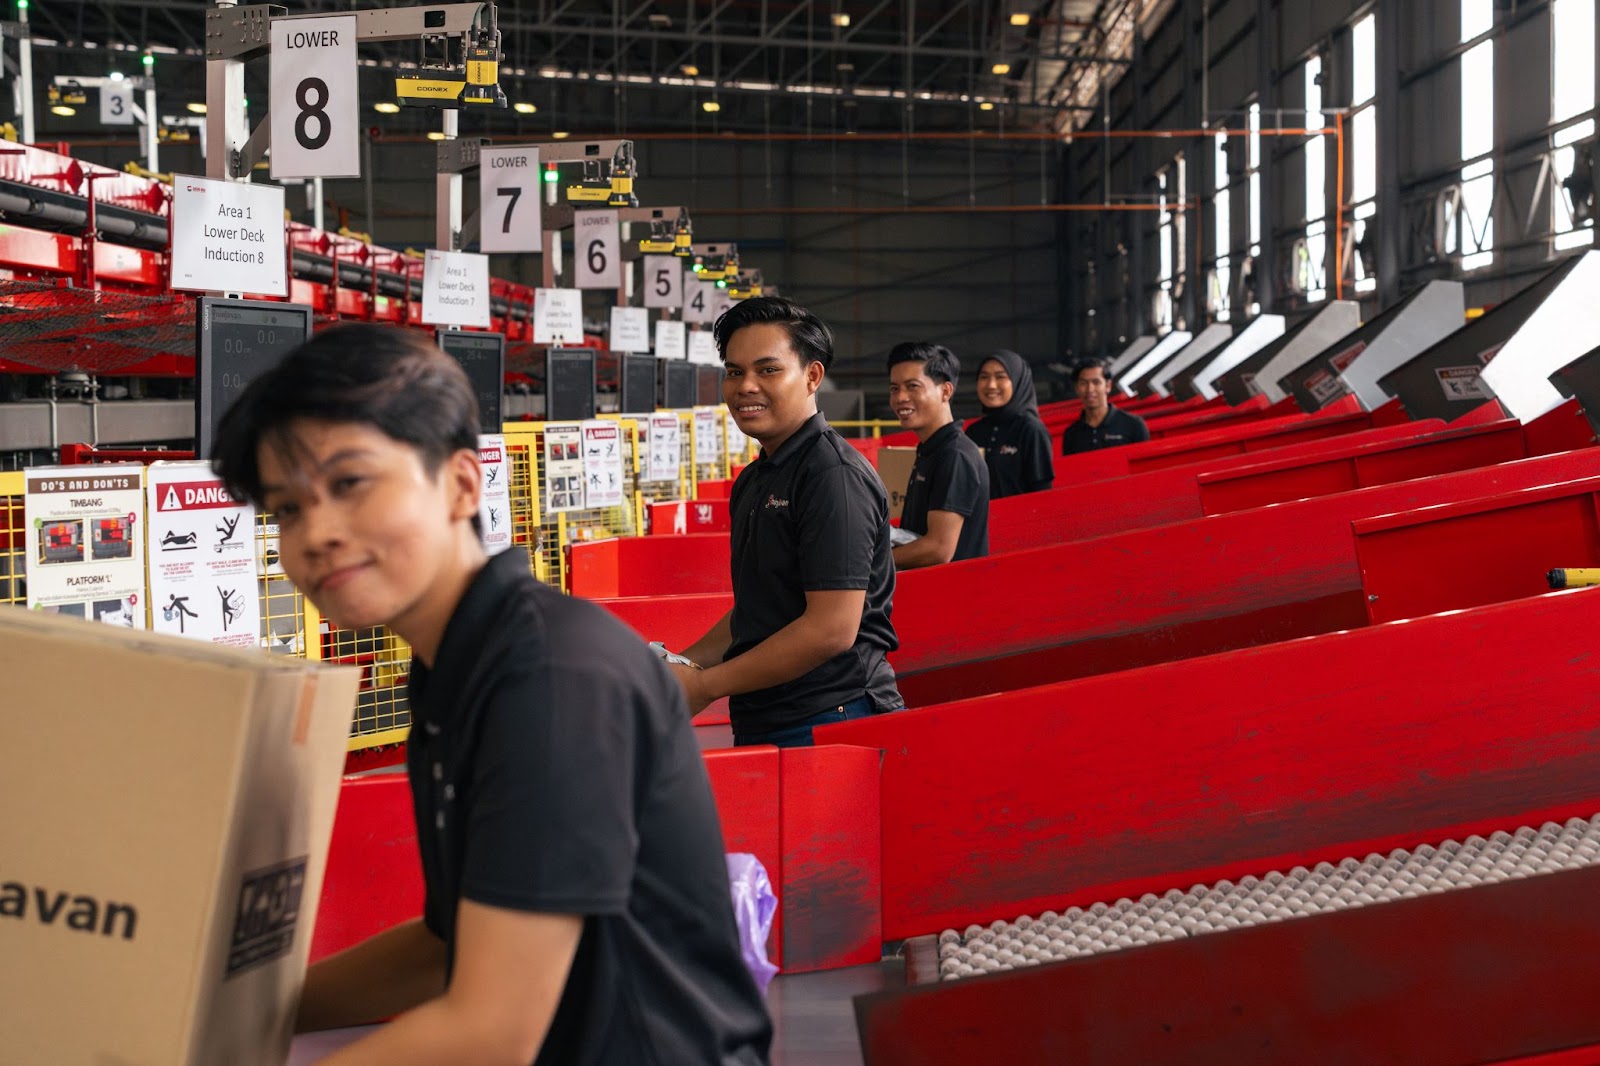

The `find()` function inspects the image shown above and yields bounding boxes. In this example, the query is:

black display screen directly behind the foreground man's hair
[195,296,312,458]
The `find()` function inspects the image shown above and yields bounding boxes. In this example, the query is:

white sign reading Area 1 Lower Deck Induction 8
[173,174,290,296]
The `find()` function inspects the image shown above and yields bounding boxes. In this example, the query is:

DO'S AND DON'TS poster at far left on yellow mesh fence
[22,464,147,629]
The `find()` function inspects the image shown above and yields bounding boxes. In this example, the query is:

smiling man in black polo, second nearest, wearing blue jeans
[674,296,906,746]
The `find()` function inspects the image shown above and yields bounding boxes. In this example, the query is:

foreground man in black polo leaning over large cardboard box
[213,325,771,1066]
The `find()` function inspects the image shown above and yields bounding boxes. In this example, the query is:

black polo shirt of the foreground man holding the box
[406,549,773,1066]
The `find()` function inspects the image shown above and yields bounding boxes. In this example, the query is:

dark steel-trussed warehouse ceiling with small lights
[21,0,1152,138]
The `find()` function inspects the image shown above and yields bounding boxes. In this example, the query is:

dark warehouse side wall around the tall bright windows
[1061,0,1600,358]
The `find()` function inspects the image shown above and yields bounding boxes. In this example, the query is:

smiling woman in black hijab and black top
[966,349,1056,499]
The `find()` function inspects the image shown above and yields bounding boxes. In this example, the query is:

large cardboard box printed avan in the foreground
[0,607,358,1066]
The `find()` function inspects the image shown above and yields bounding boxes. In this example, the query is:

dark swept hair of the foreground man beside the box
[211,325,478,523]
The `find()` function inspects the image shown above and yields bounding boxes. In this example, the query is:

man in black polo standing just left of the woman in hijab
[890,341,989,570]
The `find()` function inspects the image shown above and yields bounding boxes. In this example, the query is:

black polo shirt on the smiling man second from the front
[723,415,906,735]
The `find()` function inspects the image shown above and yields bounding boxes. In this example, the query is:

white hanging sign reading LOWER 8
[272,14,362,178]
